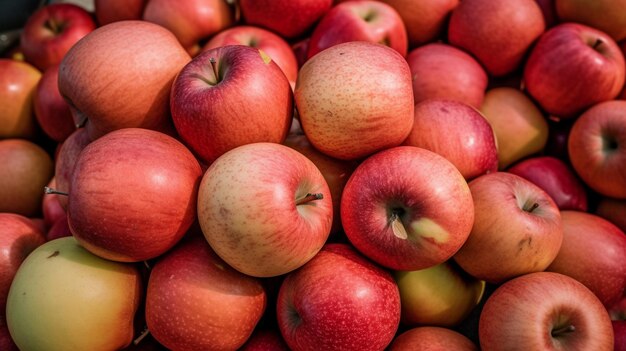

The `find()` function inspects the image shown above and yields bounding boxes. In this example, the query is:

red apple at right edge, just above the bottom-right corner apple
[547,211,626,308]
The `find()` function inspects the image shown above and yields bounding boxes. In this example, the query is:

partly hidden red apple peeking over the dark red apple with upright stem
[202,25,298,87]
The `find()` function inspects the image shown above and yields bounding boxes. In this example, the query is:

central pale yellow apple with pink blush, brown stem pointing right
[198,143,333,277]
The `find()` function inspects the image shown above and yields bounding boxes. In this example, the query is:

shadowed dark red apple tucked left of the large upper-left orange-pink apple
[33,64,76,142]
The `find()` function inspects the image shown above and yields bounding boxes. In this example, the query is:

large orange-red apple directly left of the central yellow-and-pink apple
[67,128,202,262]
